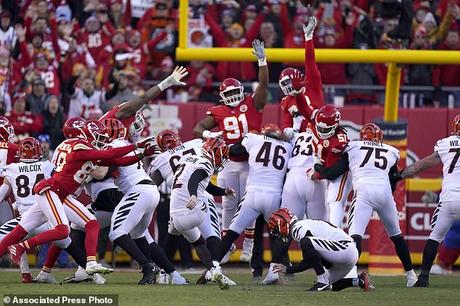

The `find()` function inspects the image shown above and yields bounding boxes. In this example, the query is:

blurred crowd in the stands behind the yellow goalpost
[0,0,460,152]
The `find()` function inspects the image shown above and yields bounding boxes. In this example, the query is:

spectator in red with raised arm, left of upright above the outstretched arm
[126,30,168,79]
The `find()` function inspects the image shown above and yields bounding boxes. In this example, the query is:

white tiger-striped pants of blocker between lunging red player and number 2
[109,184,160,241]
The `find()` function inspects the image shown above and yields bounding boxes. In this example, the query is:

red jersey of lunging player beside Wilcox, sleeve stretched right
[34,138,134,199]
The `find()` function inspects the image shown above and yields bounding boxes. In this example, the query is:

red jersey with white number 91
[206,95,262,161]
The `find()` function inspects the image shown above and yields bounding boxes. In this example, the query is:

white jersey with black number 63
[288,130,315,173]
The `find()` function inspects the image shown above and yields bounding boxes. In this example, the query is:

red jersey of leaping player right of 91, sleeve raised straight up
[281,40,324,132]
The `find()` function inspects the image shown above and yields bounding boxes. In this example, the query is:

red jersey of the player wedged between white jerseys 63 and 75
[314,127,349,167]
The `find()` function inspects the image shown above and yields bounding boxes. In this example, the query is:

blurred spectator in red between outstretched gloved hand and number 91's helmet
[187,61,215,102]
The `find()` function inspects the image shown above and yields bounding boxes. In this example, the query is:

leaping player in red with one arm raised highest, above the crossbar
[278,16,324,139]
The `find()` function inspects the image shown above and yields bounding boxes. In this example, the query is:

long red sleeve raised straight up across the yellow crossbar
[305,40,324,106]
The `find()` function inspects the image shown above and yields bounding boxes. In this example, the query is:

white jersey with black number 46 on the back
[241,133,292,192]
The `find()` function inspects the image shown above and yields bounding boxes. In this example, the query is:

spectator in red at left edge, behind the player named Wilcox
[5,92,43,139]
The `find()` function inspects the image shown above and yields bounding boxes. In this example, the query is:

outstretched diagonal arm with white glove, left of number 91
[116,66,188,119]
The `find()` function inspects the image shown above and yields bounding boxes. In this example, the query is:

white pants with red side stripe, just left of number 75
[326,172,353,228]
